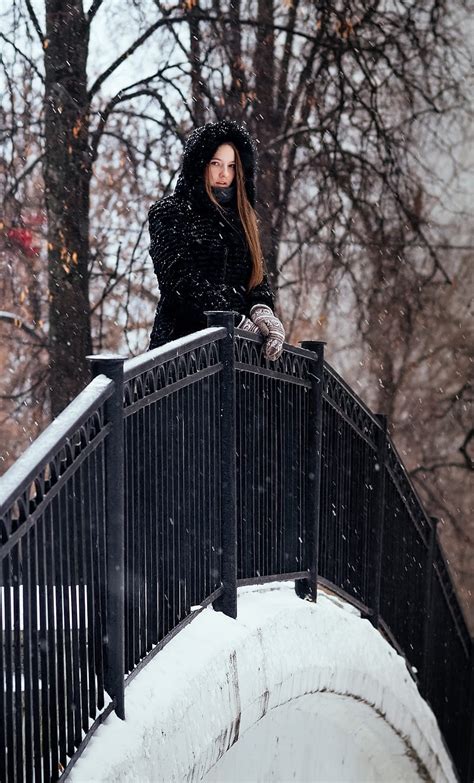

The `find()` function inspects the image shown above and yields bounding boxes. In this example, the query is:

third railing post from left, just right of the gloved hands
[295,340,326,601]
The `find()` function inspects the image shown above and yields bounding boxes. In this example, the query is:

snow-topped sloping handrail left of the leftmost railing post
[0,375,114,508]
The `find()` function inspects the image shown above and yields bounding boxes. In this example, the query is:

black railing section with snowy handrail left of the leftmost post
[0,378,113,781]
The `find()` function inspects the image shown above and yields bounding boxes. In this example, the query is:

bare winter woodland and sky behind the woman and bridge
[0,0,474,622]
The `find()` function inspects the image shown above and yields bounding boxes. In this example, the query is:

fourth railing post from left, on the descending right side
[368,413,388,628]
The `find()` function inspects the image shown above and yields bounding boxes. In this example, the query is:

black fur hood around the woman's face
[175,120,257,206]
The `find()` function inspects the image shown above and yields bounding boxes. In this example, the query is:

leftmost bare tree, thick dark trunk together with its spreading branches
[2,0,197,415]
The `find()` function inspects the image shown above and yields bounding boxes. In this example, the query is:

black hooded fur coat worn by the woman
[149,120,273,348]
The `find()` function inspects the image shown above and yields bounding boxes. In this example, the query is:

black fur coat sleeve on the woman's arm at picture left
[148,201,245,313]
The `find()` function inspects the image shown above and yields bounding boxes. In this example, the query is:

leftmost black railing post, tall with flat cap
[87,354,125,720]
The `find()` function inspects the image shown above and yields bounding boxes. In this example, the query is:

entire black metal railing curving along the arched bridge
[0,313,473,783]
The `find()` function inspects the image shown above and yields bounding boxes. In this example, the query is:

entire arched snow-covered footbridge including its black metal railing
[0,313,473,783]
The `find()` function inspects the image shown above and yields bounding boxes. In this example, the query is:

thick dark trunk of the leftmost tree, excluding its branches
[44,0,92,416]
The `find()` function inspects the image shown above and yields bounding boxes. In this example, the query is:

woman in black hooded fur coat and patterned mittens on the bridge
[149,120,285,361]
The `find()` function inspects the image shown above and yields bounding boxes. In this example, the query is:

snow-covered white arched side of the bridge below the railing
[70,583,456,783]
